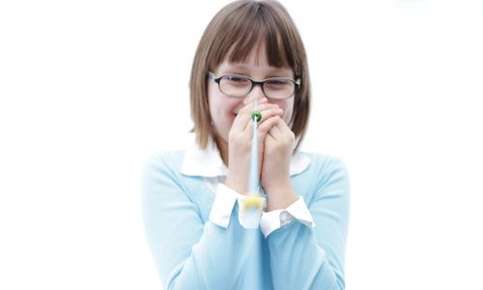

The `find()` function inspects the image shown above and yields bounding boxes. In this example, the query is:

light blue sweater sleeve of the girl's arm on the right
[267,159,350,290]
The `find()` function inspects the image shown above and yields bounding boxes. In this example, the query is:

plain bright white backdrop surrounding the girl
[0,0,483,290]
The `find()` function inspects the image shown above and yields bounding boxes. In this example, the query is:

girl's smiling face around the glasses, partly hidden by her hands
[208,40,294,142]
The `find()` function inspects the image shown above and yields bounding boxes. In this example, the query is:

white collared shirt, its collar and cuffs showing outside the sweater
[181,138,315,237]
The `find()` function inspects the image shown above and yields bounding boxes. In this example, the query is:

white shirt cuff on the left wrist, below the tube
[209,183,266,229]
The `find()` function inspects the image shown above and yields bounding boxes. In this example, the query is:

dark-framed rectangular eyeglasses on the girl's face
[208,72,300,100]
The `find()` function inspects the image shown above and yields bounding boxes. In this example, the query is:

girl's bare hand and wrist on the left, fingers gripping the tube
[225,99,283,194]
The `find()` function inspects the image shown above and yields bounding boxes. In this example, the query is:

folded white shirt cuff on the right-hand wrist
[260,196,315,238]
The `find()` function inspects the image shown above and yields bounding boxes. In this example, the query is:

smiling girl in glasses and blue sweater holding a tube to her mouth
[143,0,349,290]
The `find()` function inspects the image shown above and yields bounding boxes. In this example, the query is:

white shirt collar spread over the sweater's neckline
[181,138,310,177]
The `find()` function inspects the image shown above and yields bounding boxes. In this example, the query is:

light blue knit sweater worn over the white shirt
[143,151,350,290]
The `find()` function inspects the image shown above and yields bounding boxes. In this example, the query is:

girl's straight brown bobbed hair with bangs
[190,0,310,152]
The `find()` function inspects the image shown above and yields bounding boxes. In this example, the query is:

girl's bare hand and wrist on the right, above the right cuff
[261,116,297,211]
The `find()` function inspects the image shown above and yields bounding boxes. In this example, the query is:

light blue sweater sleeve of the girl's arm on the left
[143,158,260,290]
